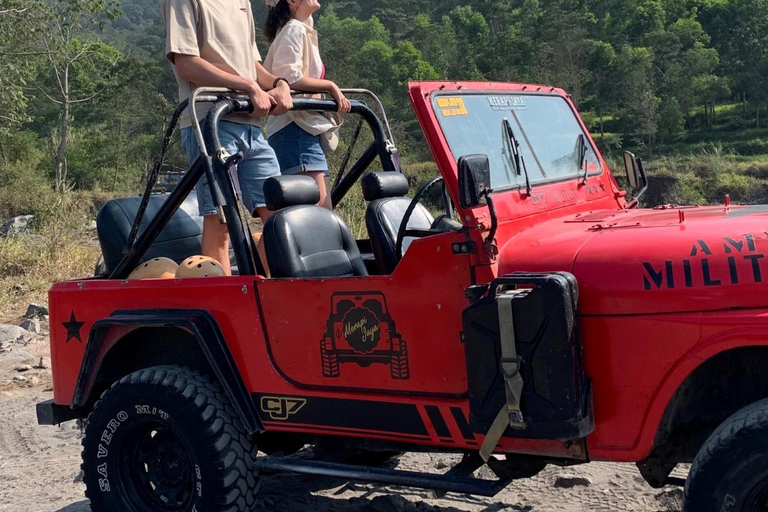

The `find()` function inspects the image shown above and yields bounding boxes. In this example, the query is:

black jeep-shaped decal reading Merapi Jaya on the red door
[320,292,410,380]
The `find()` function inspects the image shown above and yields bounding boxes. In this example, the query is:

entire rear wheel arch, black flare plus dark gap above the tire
[72,310,264,434]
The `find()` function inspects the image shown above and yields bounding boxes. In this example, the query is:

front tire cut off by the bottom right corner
[683,400,768,512]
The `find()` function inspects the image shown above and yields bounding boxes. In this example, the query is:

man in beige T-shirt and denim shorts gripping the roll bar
[162,0,293,274]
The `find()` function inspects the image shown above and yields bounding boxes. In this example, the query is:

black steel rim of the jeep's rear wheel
[120,421,195,511]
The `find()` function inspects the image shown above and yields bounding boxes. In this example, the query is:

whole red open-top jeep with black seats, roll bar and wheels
[38,83,768,512]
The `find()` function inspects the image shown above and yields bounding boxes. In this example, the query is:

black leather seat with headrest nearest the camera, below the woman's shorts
[264,176,368,278]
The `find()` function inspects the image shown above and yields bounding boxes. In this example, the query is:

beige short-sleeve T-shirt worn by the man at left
[162,0,261,128]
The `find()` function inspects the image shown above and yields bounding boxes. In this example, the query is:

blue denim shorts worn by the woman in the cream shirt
[269,123,331,176]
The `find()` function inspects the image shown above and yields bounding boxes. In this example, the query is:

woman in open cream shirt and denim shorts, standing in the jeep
[264,0,350,209]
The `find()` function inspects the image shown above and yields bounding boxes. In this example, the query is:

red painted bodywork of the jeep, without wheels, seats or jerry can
[43,83,768,494]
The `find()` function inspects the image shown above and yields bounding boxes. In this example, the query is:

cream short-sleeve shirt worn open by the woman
[264,17,335,136]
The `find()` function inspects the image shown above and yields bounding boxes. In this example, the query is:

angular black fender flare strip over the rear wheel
[72,309,265,434]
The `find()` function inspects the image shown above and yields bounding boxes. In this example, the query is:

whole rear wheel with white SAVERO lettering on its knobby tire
[82,366,258,512]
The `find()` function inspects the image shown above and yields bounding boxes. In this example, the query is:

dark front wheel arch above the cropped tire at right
[637,340,768,487]
